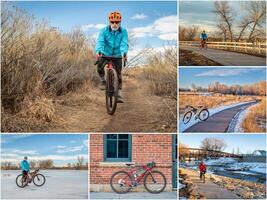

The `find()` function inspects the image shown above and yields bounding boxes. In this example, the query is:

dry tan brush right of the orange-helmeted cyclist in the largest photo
[139,46,177,127]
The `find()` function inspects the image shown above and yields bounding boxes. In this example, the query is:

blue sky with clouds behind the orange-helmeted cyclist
[9,1,177,55]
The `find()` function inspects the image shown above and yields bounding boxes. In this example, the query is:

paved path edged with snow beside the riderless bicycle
[184,102,256,133]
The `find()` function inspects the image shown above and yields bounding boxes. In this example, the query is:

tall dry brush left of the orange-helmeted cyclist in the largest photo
[1,2,97,131]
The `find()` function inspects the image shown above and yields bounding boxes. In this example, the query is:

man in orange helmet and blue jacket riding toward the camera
[95,12,129,103]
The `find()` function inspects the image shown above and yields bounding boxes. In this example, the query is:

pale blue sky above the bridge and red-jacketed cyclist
[179,134,266,153]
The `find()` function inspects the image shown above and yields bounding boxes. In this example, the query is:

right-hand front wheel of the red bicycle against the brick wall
[144,170,167,194]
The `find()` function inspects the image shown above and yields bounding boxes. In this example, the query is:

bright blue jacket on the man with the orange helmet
[95,26,129,56]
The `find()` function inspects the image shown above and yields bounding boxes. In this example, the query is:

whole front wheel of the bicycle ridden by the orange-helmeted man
[106,69,119,115]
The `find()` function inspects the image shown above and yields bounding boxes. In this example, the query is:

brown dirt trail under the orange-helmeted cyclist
[46,77,176,133]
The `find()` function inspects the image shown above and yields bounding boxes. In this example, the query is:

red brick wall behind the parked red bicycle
[90,134,175,191]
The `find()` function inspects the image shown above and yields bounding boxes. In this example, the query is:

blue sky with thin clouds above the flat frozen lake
[1,134,88,166]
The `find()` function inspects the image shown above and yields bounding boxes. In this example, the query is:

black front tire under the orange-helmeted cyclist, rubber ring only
[106,69,119,115]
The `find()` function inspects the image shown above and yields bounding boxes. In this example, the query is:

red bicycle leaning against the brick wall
[110,162,167,194]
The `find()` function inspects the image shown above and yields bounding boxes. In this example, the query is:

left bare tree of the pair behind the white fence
[213,1,234,42]
